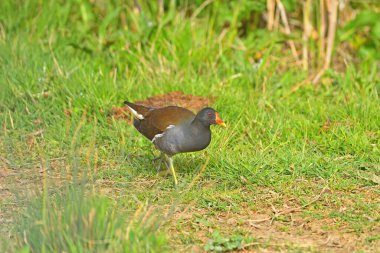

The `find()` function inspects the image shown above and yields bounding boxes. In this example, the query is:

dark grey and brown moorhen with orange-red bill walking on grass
[124,101,226,186]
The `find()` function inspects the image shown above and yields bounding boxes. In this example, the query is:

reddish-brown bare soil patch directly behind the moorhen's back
[111,91,215,119]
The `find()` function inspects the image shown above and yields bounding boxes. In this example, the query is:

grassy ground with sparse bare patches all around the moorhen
[0,0,380,252]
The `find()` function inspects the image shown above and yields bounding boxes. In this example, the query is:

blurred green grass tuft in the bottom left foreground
[12,186,167,252]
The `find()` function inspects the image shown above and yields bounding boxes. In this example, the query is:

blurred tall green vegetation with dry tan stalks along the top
[0,0,380,87]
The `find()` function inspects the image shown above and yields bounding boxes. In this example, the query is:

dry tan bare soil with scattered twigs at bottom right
[168,185,380,252]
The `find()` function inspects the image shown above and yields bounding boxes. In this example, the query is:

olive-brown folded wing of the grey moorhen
[135,106,195,140]
